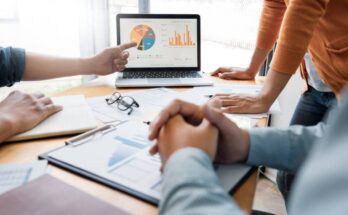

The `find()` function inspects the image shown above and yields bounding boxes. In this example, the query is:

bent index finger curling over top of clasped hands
[149,100,203,140]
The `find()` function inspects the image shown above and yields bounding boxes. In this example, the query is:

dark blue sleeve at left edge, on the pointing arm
[0,47,25,87]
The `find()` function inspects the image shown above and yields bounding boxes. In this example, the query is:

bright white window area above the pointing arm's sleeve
[0,0,80,56]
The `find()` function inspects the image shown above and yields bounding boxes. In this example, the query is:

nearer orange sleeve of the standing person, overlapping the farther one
[270,0,330,74]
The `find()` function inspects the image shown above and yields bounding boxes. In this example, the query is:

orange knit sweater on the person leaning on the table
[256,0,348,95]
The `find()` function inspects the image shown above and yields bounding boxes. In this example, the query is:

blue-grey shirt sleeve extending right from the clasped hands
[247,123,326,172]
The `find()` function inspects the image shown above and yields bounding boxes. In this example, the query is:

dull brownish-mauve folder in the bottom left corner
[0,175,127,215]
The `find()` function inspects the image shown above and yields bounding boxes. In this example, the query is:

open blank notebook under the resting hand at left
[10,95,97,141]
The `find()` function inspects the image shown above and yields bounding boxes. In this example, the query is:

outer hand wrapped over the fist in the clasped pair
[149,100,249,166]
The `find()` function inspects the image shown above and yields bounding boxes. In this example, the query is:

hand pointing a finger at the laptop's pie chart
[90,43,137,75]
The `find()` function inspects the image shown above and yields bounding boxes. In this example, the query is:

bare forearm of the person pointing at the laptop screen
[23,52,93,80]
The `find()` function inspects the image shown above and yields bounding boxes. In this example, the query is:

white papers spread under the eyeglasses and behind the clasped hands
[87,85,280,128]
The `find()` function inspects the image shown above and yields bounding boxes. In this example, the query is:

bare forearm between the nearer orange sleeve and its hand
[260,69,291,109]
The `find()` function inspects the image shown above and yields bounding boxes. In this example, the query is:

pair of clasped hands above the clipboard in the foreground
[149,100,249,167]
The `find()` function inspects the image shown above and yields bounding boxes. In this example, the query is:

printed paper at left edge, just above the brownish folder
[0,161,47,194]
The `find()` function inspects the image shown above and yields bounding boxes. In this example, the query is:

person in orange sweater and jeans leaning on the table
[212,0,348,206]
